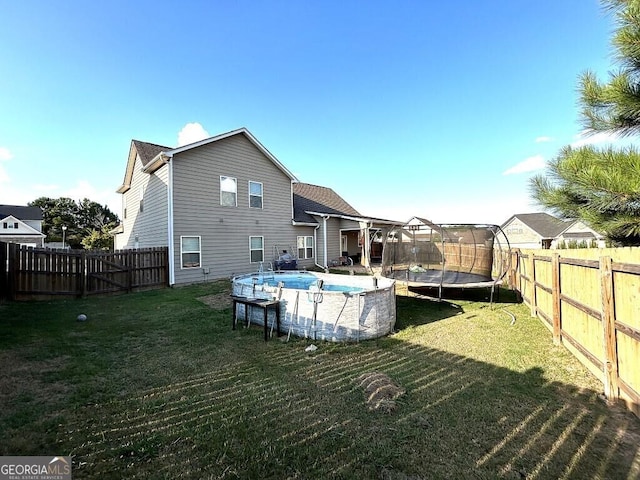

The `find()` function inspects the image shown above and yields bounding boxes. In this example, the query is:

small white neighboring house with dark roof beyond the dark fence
[0,205,45,247]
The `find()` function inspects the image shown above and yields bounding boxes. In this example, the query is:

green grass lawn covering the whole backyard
[0,282,640,480]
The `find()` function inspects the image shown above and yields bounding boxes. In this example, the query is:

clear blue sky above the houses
[0,0,614,223]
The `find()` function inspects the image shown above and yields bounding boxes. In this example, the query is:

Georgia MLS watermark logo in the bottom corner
[0,457,71,480]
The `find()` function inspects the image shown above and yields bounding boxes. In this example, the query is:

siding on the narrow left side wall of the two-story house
[115,157,168,249]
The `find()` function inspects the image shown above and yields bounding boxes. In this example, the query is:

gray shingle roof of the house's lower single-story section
[293,183,361,223]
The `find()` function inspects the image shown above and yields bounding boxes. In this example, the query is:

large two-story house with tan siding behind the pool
[113,128,393,284]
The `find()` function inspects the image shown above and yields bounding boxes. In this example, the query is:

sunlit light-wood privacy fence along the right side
[509,248,640,416]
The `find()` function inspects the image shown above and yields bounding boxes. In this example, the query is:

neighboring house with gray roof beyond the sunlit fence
[502,213,604,249]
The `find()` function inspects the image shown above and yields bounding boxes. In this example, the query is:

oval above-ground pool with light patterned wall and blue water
[232,271,396,342]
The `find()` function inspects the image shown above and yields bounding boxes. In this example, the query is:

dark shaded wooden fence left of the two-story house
[0,243,169,300]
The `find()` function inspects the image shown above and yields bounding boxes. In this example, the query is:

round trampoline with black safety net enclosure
[382,219,511,301]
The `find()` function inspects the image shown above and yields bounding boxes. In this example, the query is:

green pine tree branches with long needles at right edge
[531,0,640,245]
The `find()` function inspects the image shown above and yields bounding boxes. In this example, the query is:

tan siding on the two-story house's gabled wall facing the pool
[173,134,298,283]
